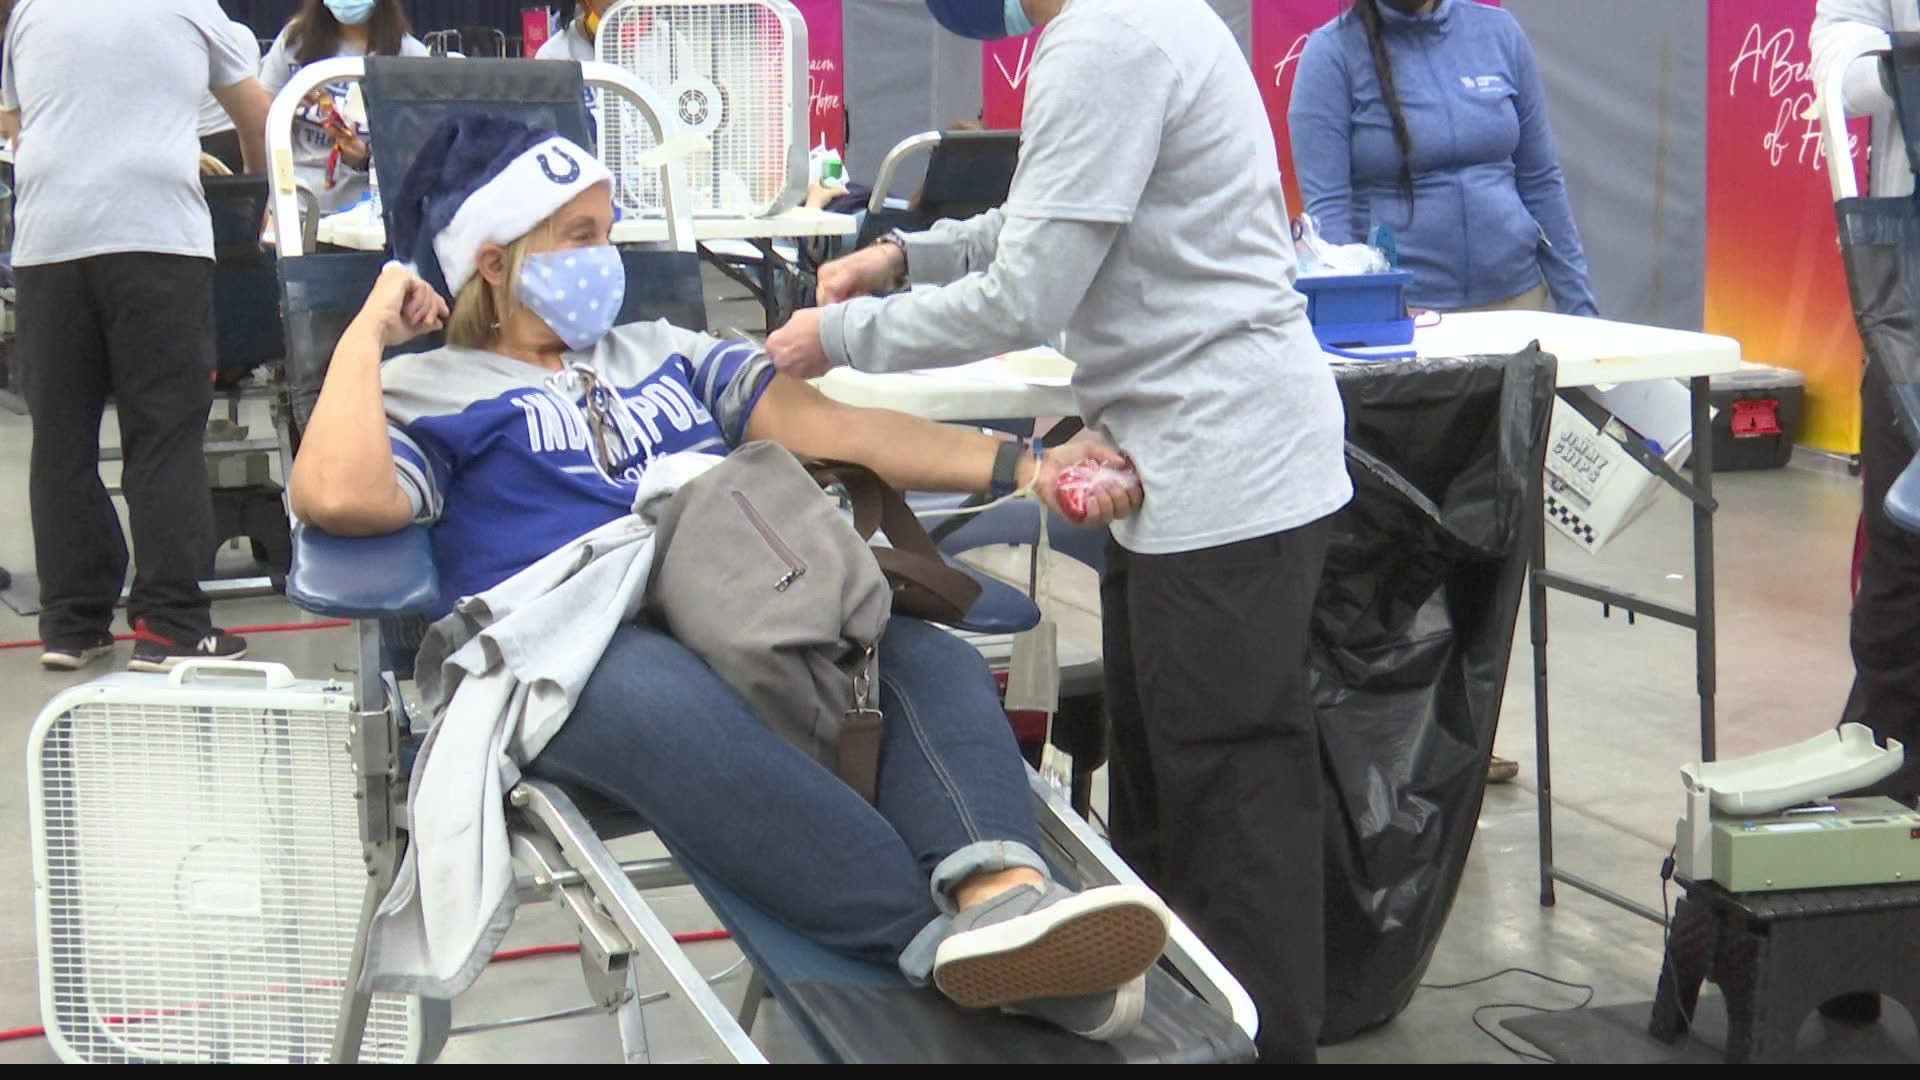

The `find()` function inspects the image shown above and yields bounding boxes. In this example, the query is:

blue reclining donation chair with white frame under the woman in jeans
[271,60,1256,1063]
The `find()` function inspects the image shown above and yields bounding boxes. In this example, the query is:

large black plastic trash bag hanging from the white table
[1311,346,1555,1043]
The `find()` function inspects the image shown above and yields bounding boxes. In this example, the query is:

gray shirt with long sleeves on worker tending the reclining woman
[822,0,1352,555]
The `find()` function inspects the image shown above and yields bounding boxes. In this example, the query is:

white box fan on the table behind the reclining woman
[597,0,803,217]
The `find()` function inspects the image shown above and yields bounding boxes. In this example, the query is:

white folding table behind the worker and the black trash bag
[818,311,1741,920]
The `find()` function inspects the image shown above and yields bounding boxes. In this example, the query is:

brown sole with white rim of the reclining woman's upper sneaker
[933,888,1171,1006]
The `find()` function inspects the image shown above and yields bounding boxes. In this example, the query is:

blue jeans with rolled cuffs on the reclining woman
[532,617,1046,978]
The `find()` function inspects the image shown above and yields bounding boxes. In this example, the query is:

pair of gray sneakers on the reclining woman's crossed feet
[933,884,1173,1040]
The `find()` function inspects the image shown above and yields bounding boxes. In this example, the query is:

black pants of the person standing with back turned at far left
[13,254,213,646]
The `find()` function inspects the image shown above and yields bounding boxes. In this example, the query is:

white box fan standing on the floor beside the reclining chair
[36,687,419,1063]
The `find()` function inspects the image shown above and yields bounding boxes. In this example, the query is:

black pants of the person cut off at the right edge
[1845,363,1920,799]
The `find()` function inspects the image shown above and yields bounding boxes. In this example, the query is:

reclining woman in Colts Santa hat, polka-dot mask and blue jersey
[292,115,1169,1040]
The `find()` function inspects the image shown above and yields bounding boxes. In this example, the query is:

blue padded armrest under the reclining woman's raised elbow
[286,525,440,619]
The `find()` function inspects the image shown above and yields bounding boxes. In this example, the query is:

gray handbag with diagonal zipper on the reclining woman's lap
[647,442,893,801]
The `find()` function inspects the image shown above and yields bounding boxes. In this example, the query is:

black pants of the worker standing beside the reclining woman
[1100,521,1331,1063]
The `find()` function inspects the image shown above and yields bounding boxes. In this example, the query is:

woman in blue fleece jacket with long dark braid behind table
[1288,0,1597,315]
